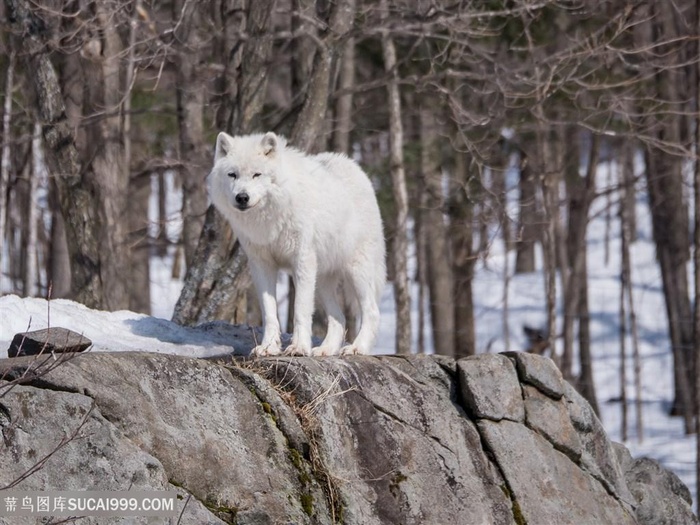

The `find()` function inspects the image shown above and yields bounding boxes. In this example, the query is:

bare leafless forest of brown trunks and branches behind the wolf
[0,0,700,508]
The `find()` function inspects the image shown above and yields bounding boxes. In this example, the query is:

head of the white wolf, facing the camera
[208,132,285,213]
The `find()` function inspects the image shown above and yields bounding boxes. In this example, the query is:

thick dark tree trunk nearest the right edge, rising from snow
[634,1,695,433]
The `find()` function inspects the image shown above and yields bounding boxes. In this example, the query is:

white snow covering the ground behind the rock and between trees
[0,161,696,508]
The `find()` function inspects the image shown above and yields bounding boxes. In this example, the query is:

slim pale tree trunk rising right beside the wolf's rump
[382,0,411,354]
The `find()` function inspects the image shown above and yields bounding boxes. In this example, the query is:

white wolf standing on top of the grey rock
[208,133,386,356]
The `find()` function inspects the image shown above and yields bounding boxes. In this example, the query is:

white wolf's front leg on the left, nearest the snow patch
[249,258,282,357]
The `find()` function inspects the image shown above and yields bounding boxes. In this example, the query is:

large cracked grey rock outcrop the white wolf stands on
[0,352,697,525]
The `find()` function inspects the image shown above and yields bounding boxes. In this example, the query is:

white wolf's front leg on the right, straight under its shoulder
[284,249,317,356]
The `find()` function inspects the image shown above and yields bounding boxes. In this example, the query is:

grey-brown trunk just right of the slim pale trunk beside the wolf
[420,104,455,356]
